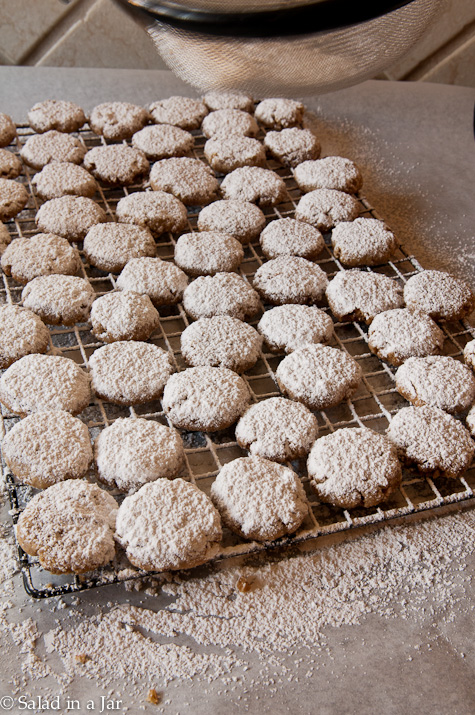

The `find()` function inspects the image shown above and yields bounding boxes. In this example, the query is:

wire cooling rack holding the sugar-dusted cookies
[0,119,475,598]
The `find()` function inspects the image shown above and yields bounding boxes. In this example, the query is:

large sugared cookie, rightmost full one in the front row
[387,405,475,478]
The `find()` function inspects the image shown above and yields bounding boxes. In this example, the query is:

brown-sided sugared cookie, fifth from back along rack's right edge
[331,218,398,267]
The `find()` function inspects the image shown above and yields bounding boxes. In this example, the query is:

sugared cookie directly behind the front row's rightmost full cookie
[396,355,475,413]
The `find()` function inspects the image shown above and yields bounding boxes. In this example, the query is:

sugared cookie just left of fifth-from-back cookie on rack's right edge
[259,218,325,261]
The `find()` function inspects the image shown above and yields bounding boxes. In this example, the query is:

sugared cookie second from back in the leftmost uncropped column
[20,129,87,169]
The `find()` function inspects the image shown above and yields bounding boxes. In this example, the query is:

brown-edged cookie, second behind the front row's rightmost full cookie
[368,308,445,367]
